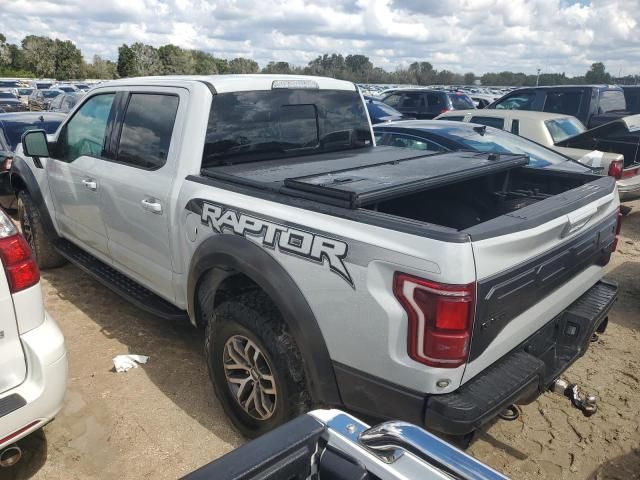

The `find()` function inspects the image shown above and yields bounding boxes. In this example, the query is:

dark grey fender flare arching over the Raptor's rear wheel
[187,234,342,405]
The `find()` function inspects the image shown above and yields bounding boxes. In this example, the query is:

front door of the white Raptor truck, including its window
[46,93,115,259]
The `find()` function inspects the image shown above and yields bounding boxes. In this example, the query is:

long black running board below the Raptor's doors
[54,239,189,320]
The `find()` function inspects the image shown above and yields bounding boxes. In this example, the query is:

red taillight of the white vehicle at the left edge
[0,210,40,293]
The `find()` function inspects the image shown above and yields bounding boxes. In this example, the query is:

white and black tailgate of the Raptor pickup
[462,178,619,382]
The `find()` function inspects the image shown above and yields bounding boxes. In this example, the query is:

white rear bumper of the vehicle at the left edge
[0,314,67,449]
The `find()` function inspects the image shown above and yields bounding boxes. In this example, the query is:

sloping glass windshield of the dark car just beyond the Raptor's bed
[440,124,569,168]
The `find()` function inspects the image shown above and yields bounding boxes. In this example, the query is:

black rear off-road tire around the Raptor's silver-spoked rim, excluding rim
[203,291,310,438]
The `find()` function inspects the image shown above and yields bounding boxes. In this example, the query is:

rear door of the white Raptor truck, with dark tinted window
[96,87,187,300]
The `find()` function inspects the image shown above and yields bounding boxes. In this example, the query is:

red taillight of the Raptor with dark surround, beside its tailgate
[393,272,475,368]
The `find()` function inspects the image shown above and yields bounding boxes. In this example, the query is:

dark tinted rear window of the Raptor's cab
[202,88,372,168]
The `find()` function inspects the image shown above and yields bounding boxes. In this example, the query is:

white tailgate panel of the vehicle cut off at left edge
[0,268,27,395]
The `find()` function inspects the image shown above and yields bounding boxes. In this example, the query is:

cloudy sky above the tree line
[0,0,640,75]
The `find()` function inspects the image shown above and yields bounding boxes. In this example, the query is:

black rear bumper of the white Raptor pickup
[335,280,618,435]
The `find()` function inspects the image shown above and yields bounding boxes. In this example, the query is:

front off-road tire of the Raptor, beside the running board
[18,190,67,270]
